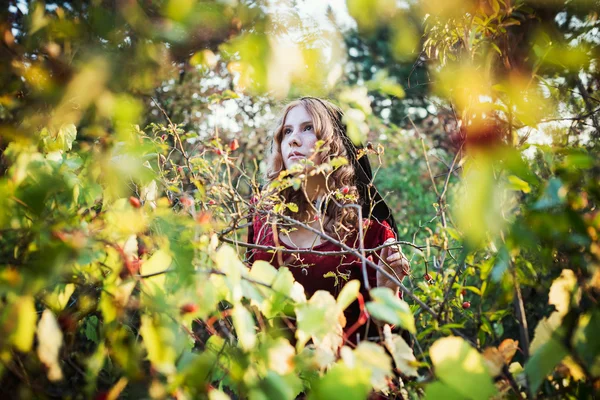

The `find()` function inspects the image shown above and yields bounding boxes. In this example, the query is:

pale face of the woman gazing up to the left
[281,105,317,169]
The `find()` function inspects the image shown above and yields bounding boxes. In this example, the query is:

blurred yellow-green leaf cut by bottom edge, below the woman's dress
[308,362,371,400]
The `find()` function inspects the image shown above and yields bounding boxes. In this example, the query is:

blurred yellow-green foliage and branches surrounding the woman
[0,0,600,399]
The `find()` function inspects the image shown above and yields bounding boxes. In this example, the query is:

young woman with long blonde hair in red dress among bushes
[248,97,410,341]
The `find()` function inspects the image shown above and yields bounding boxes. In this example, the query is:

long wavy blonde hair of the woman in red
[266,97,358,237]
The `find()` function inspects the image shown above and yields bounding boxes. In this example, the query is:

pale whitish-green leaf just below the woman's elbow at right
[367,287,416,333]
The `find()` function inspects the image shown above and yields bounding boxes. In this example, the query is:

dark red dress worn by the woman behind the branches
[249,215,396,342]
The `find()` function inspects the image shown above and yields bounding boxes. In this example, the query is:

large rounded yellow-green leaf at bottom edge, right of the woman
[429,336,496,400]
